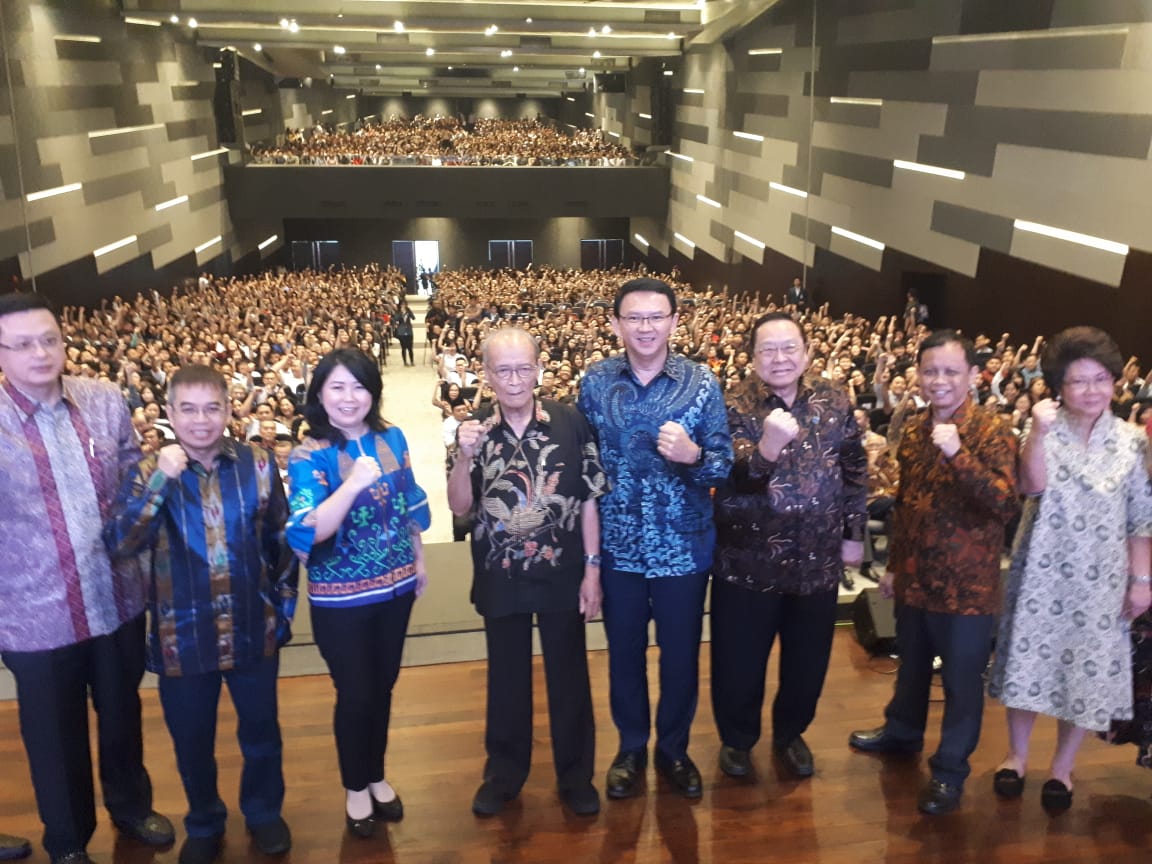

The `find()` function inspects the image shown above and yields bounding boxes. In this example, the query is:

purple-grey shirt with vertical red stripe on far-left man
[0,377,144,651]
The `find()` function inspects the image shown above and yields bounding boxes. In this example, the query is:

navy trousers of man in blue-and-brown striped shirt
[159,655,285,838]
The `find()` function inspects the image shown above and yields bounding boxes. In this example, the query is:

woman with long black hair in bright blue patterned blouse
[288,348,430,838]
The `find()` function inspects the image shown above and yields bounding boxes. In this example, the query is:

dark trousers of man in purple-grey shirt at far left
[2,615,152,858]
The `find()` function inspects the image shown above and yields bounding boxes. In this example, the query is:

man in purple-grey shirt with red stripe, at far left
[0,293,173,864]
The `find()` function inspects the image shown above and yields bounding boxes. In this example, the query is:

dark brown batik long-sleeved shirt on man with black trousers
[713,377,867,594]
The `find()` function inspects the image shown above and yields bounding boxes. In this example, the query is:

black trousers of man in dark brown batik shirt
[712,579,836,750]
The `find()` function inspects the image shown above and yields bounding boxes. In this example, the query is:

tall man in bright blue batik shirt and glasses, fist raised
[579,279,733,798]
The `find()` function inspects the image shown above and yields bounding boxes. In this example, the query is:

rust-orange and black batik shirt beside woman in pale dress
[888,400,1020,615]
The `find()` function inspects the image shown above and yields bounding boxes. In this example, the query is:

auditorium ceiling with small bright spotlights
[122,0,776,96]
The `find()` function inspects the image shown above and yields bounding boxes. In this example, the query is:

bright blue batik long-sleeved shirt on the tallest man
[578,351,733,577]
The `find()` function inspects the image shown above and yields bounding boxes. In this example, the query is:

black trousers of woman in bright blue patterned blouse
[312,591,416,790]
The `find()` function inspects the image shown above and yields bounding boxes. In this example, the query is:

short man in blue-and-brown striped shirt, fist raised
[105,364,296,864]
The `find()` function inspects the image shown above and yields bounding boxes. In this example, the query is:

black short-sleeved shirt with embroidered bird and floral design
[471,399,608,617]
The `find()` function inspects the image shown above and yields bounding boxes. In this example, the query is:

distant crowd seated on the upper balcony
[252,115,637,166]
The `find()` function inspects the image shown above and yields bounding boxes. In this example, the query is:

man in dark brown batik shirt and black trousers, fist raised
[712,312,867,778]
